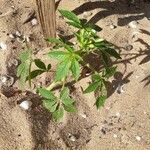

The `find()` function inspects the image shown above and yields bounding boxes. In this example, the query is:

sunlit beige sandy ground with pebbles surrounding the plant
[0,0,150,150]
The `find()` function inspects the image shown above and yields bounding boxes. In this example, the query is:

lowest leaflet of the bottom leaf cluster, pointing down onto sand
[52,108,64,122]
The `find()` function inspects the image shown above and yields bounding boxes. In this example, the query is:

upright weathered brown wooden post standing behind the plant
[36,0,56,41]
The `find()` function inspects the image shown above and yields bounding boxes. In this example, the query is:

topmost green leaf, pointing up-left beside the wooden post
[59,10,80,23]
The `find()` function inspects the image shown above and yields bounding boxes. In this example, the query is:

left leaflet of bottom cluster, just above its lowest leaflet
[43,99,58,112]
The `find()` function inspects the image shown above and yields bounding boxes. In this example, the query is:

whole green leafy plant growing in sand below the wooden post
[17,10,121,121]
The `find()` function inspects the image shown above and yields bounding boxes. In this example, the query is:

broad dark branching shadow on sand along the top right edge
[73,0,150,26]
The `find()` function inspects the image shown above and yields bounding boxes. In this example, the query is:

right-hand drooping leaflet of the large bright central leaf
[71,59,80,81]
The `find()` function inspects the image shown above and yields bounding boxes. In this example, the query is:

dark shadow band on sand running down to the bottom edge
[24,92,60,150]
